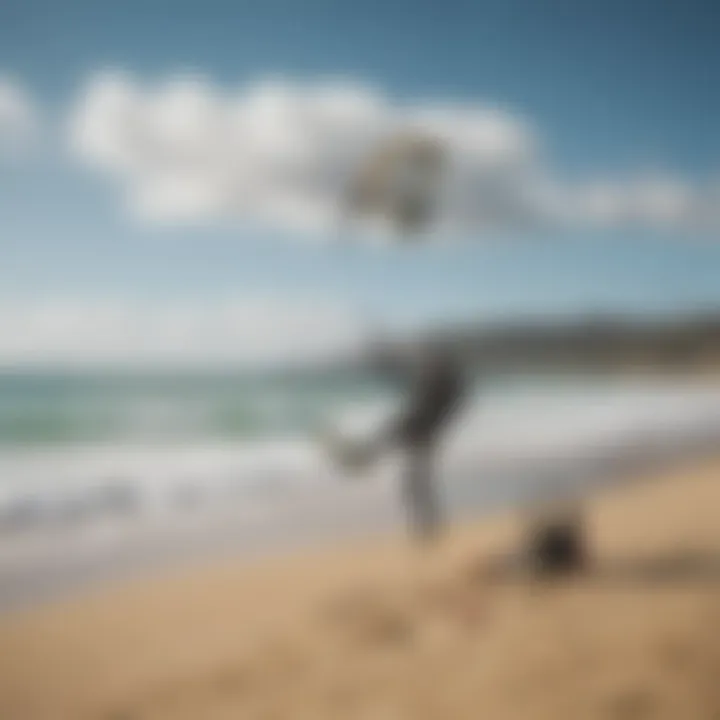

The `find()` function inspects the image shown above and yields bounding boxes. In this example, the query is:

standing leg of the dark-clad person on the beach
[403,443,442,542]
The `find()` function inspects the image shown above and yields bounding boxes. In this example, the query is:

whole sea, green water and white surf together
[0,371,720,534]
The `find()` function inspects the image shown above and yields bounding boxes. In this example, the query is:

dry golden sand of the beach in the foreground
[0,460,720,720]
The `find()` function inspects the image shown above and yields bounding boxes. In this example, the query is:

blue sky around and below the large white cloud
[0,0,720,362]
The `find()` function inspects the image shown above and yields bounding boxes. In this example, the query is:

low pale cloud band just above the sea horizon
[0,297,362,366]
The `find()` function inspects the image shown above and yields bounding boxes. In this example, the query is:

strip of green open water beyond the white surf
[0,372,392,448]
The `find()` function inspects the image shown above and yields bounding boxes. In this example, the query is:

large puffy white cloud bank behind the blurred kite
[70,73,710,232]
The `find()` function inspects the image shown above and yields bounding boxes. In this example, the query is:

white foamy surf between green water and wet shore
[0,381,720,530]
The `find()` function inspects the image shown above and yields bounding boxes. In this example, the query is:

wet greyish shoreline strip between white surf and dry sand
[0,428,719,619]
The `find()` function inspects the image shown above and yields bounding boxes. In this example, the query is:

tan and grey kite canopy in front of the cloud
[346,131,445,235]
